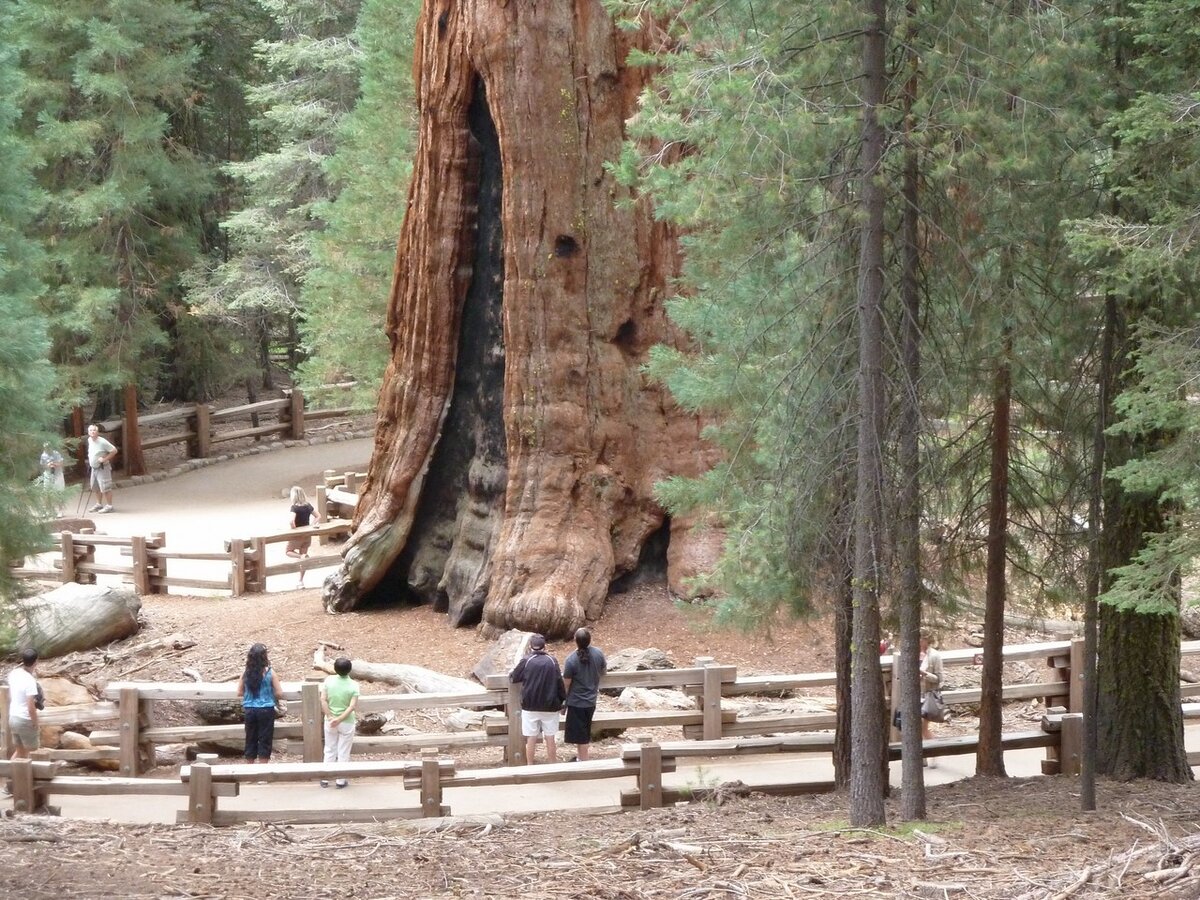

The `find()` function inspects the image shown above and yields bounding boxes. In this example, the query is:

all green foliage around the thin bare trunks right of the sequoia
[616,2,1097,618]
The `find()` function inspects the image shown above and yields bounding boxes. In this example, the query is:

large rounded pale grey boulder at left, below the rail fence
[7,583,142,658]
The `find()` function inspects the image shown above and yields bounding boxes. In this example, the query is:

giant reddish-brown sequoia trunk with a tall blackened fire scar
[325,0,715,635]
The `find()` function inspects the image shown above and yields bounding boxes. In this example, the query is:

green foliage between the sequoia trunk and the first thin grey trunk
[616,2,859,625]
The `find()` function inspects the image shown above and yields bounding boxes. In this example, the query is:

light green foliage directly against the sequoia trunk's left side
[300,0,420,406]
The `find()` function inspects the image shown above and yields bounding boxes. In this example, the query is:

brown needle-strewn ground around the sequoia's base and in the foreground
[11,583,1200,900]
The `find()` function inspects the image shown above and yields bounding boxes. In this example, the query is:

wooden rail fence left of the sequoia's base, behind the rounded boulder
[12,470,365,596]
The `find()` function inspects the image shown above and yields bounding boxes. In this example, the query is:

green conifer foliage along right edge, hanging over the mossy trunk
[1070,0,1200,614]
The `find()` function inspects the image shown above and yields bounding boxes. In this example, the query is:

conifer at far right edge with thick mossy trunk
[1074,0,1200,781]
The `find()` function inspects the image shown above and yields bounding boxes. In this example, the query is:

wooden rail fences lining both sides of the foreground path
[0,641,1200,824]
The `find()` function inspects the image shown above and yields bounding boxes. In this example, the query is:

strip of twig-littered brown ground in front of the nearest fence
[0,779,1200,900]
